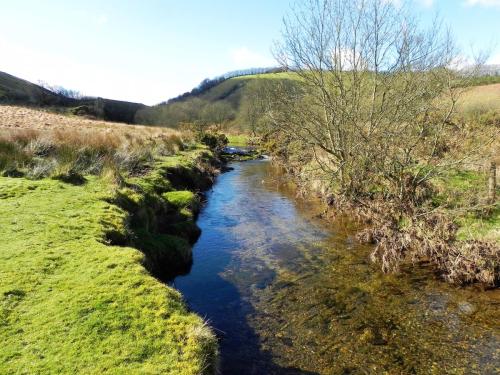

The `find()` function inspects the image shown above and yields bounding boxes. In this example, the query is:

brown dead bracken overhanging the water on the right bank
[352,201,500,286]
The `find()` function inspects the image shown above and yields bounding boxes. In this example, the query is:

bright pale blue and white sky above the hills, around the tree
[0,0,500,104]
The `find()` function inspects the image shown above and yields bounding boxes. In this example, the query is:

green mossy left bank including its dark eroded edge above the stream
[0,150,217,375]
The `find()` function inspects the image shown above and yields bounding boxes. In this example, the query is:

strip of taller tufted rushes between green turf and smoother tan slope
[0,127,191,180]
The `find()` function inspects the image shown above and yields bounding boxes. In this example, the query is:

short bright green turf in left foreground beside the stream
[0,153,216,374]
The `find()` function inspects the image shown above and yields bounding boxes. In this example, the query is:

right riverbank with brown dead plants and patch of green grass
[266,138,500,287]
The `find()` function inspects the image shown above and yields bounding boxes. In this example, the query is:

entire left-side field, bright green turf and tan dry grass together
[0,106,217,375]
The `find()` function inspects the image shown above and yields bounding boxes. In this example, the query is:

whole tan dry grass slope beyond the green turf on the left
[0,106,191,181]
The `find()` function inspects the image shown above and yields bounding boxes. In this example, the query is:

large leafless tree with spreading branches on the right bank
[269,0,488,206]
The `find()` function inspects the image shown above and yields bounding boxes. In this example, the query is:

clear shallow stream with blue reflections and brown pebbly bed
[173,161,500,375]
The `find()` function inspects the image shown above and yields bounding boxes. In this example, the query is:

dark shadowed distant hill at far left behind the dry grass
[0,72,146,123]
